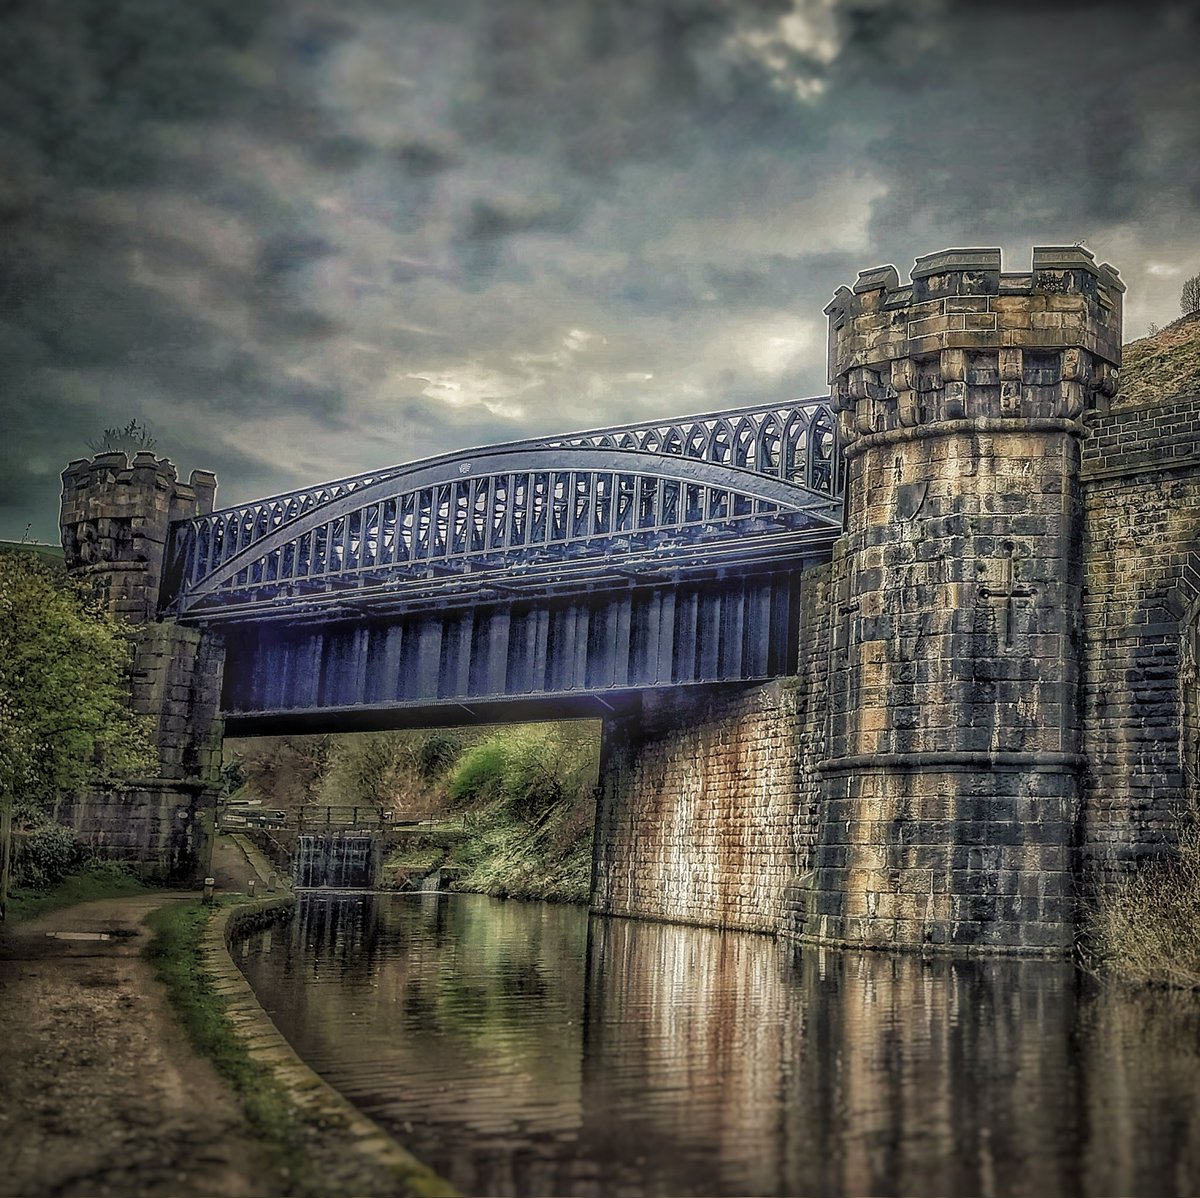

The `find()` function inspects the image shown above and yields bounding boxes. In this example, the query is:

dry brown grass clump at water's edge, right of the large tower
[1087,827,1200,989]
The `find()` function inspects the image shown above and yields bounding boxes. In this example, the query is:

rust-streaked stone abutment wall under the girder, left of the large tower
[593,567,828,932]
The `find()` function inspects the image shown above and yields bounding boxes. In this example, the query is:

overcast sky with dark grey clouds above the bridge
[0,0,1200,540]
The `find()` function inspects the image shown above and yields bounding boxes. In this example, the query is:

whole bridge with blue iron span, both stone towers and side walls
[62,246,1200,954]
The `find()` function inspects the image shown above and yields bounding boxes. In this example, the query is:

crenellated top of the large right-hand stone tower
[826,246,1124,455]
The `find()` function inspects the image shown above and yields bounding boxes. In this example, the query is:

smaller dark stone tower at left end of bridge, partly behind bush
[58,453,222,882]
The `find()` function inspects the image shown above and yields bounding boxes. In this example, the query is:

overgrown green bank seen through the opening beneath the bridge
[226,720,600,903]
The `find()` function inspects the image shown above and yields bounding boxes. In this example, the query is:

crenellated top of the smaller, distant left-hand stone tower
[60,451,217,623]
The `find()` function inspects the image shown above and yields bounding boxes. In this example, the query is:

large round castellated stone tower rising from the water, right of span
[799,247,1124,953]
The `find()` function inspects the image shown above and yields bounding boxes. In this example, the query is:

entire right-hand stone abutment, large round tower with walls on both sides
[595,248,1200,954]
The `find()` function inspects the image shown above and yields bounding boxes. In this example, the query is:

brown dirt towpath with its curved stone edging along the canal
[0,846,452,1198]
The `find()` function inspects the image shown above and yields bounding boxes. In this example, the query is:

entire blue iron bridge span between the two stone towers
[163,399,842,735]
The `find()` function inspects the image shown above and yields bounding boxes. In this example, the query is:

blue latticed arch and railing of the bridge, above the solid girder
[172,400,841,616]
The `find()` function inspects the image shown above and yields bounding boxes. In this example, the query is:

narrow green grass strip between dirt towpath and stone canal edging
[146,903,312,1194]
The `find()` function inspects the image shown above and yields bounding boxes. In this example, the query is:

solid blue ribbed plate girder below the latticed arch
[222,563,803,736]
